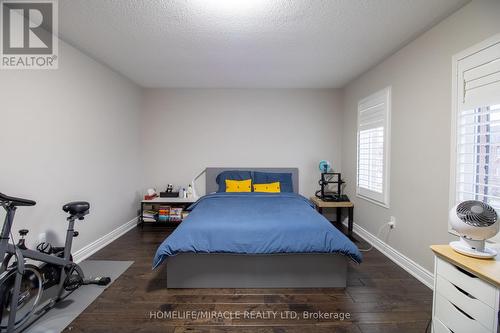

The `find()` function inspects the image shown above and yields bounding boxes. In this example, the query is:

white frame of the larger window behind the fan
[448,34,500,242]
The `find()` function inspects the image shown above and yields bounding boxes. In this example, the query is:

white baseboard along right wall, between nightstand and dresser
[353,223,434,289]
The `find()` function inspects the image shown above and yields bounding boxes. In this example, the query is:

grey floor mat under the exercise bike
[25,260,134,333]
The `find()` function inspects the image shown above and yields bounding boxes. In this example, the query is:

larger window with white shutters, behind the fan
[450,35,500,241]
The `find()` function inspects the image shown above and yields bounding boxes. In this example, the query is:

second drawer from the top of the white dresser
[436,275,496,331]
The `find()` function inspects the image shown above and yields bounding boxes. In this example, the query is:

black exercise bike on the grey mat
[0,193,111,333]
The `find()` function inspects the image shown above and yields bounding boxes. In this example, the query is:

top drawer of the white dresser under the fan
[436,258,497,308]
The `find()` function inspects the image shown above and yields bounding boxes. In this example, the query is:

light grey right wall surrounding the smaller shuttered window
[342,0,500,271]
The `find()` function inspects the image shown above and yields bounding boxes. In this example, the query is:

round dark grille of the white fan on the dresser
[457,200,497,227]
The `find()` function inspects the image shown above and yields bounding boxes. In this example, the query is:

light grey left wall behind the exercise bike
[0,42,141,251]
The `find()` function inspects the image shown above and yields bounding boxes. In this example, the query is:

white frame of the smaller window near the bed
[356,86,392,208]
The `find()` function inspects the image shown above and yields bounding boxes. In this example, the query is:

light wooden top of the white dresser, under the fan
[431,245,500,287]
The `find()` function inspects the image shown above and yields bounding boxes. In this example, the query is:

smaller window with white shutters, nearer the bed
[356,87,391,207]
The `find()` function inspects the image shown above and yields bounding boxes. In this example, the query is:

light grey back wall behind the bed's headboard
[141,89,342,195]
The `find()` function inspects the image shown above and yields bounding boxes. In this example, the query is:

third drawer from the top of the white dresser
[434,293,491,333]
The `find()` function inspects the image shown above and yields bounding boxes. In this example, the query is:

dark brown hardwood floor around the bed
[65,227,432,333]
